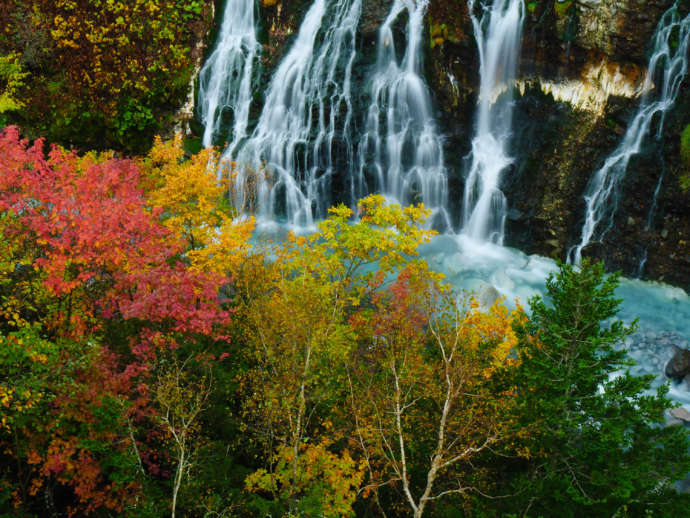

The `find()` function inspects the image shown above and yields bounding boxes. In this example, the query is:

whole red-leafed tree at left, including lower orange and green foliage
[0,128,232,513]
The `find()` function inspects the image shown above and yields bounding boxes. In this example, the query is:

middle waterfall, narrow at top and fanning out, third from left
[351,0,452,230]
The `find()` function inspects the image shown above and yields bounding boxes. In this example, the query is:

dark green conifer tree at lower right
[502,261,690,518]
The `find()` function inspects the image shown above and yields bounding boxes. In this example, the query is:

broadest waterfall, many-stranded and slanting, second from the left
[230,0,362,227]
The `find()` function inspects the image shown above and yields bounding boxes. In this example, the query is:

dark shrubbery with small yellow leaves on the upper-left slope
[0,0,210,152]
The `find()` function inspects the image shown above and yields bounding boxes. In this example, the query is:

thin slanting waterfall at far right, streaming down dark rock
[568,5,690,264]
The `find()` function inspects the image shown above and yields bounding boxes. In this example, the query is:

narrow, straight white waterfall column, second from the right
[463,0,525,245]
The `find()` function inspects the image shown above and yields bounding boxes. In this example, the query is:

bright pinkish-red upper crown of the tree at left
[0,128,229,344]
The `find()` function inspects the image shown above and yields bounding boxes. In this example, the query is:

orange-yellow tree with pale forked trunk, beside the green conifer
[348,264,517,518]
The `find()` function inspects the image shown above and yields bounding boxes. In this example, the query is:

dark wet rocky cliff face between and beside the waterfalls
[203,0,690,288]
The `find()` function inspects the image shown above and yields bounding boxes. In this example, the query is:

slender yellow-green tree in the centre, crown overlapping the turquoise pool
[237,196,432,516]
